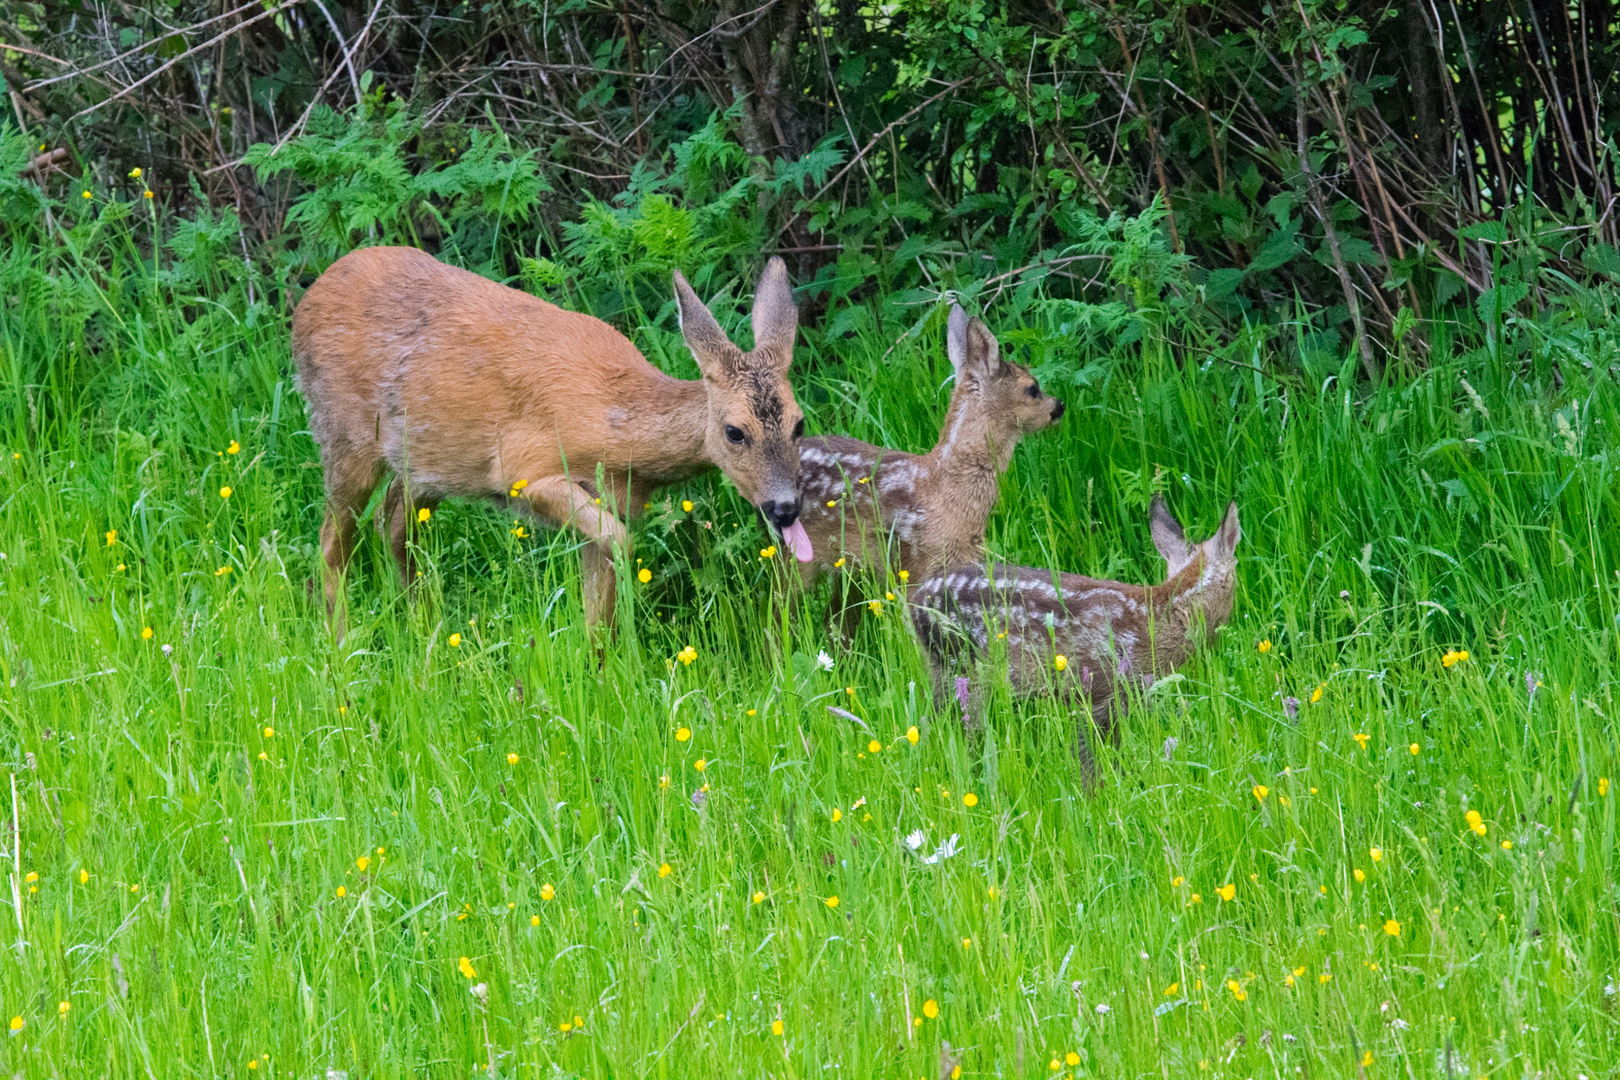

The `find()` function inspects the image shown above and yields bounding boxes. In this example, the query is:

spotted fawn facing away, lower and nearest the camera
[912,495,1241,782]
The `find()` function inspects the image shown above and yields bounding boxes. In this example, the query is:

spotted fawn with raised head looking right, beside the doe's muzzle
[799,304,1063,625]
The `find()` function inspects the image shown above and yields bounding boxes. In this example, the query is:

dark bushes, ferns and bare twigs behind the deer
[9,0,1620,377]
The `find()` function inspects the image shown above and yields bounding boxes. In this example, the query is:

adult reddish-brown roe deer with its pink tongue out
[292,248,810,638]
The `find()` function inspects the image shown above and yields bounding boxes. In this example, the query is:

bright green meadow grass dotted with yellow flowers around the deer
[0,213,1620,1080]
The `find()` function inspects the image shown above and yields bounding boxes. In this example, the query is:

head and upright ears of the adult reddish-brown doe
[676,257,805,534]
